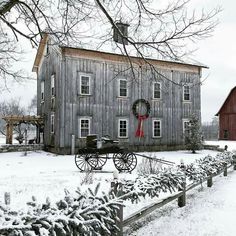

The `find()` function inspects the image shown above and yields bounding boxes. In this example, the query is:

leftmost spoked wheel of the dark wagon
[75,153,98,171]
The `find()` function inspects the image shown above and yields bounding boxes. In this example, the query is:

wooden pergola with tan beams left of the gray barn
[2,115,43,144]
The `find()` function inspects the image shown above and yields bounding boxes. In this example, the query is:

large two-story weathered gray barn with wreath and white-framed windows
[33,35,205,153]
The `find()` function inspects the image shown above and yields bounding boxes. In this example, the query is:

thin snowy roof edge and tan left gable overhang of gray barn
[32,34,209,72]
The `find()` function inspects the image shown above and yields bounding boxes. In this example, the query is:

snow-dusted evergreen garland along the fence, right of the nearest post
[122,152,235,202]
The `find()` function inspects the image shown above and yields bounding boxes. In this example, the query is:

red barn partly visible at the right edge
[216,87,236,140]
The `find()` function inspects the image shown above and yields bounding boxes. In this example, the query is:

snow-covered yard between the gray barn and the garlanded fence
[0,150,216,211]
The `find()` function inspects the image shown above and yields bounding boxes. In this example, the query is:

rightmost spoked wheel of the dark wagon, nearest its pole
[113,152,137,172]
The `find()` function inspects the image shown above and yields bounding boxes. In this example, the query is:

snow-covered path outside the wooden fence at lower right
[129,171,236,236]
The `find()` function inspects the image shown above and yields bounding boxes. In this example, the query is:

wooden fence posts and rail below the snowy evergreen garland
[112,163,236,236]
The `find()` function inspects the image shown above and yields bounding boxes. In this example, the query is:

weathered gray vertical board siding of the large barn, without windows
[38,46,200,153]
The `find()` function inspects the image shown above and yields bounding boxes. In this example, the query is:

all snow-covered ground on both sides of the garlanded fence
[0,142,236,236]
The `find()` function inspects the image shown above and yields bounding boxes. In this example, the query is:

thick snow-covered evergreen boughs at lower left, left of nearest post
[0,186,122,236]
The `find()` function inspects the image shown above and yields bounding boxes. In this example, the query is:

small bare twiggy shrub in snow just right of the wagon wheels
[137,158,162,175]
